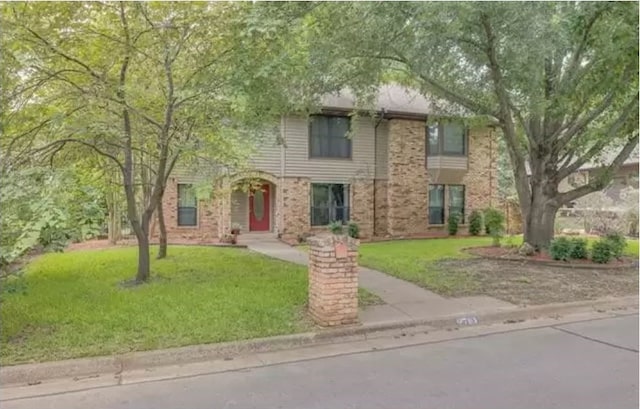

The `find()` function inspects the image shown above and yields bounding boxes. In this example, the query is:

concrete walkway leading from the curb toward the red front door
[243,236,517,324]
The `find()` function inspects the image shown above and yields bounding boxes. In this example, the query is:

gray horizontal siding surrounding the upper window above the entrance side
[284,117,375,183]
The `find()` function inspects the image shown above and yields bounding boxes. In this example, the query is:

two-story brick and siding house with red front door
[152,85,498,241]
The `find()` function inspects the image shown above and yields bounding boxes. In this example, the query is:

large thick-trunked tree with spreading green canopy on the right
[304,2,638,247]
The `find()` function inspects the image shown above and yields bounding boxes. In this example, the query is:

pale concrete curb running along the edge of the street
[0,296,638,386]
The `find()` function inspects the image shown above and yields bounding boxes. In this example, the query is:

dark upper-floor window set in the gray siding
[309,115,351,159]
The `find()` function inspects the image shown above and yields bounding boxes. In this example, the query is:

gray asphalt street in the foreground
[0,315,638,409]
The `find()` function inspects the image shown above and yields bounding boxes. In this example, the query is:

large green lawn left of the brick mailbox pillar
[0,246,381,365]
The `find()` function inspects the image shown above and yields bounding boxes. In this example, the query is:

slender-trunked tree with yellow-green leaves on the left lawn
[2,2,302,282]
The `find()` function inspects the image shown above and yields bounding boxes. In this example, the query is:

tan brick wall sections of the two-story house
[158,119,502,243]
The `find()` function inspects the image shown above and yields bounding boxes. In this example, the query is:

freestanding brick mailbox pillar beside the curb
[308,235,358,326]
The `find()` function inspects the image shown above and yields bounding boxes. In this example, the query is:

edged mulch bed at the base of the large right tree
[465,246,638,270]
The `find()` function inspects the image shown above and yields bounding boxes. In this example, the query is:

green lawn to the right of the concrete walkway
[359,236,638,295]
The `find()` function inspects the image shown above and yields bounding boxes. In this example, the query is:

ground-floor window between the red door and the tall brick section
[311,183,349,226]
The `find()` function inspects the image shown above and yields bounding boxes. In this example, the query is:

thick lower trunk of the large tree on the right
[524,192,558,250]
